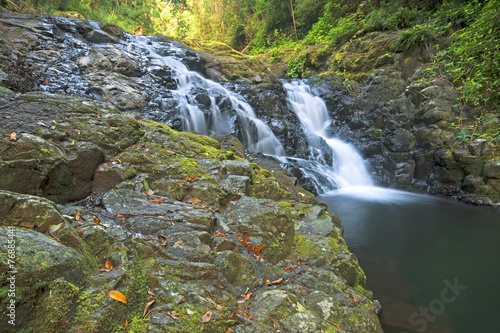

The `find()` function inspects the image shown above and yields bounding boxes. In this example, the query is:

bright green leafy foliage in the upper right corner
[428,0,500,109]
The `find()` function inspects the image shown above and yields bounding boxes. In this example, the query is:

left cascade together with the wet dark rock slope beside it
[36,17,284,156]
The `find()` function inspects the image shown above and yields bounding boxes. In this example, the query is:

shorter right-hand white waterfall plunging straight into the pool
[284,81,373,192]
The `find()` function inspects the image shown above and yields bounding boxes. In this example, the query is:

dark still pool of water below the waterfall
[319,188,500,333]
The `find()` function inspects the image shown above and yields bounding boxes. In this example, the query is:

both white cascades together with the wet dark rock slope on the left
[33,17,373,189]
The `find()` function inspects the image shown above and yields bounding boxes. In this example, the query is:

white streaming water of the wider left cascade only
[131,36,285,156]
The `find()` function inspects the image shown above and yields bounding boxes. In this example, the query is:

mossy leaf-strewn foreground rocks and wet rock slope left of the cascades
[0,12,382,332]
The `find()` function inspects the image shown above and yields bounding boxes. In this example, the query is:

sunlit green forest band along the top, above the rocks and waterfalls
[0,0,500,111]
